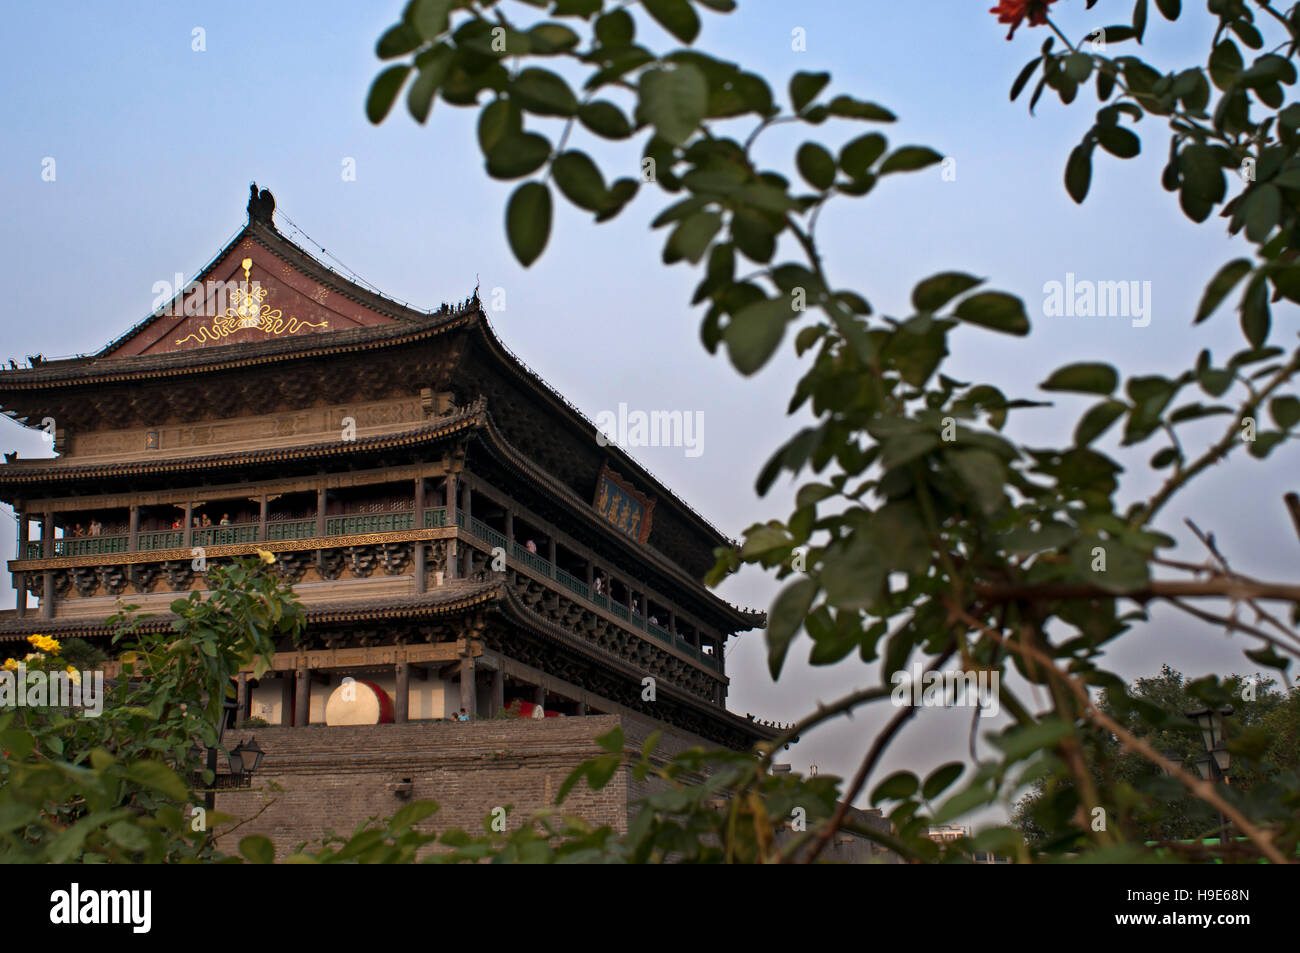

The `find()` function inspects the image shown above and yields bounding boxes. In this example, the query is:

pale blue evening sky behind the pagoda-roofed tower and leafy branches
[0,0,1297,816]
